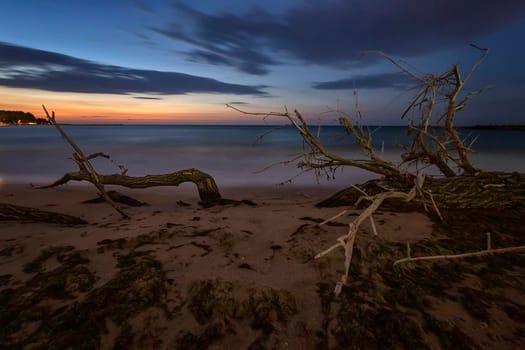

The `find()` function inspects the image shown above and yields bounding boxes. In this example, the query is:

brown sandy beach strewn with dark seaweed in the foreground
[0,184,525,349]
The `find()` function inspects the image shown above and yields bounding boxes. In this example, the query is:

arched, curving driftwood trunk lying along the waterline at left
[37,169,225,207]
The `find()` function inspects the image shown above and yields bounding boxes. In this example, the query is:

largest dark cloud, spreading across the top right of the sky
[154,0,525,75]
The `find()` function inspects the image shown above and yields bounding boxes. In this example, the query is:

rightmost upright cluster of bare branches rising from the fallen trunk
[376,45,489,177]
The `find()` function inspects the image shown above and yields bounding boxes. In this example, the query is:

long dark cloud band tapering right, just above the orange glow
[0,43,266,95]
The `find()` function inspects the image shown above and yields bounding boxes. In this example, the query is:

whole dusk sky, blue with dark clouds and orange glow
[0,0,525,125]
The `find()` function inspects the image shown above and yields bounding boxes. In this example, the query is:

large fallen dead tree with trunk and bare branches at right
[228,45,525,294]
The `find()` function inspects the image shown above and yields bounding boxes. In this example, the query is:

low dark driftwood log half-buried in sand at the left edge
[0,203,87,225]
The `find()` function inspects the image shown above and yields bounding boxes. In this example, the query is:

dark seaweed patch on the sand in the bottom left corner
[0,252,172,349]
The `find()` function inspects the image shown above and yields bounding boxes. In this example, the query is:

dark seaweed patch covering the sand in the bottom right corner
[317,210,525,349]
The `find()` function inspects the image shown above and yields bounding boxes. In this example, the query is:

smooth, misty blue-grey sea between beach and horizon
[0,125,525,187]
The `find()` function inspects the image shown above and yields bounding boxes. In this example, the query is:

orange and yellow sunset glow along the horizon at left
[0,87,270,124]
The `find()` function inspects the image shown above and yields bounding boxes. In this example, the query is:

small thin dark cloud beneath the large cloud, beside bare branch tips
[312,73,417,90]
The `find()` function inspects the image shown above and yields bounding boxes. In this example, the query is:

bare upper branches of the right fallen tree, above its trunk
[231,45,488,184]
